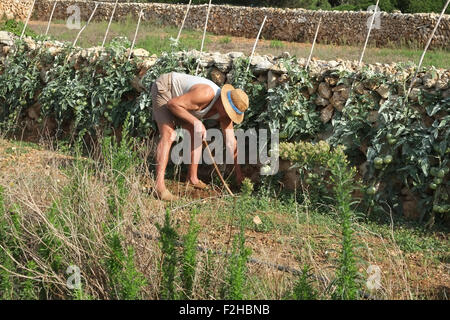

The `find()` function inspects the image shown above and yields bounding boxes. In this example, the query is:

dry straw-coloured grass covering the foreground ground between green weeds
[0,140,450,299]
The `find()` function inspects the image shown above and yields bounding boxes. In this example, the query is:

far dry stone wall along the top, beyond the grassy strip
[0,0,450,48]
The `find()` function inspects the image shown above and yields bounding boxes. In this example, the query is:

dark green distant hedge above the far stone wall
[144,0,450,14]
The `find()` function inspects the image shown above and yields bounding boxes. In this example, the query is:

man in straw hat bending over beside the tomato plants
[151,72,249,201]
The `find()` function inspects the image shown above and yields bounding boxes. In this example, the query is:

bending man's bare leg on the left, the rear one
[156,123,175,200]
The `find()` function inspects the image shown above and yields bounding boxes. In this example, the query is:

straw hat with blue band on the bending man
[220,84,248,124]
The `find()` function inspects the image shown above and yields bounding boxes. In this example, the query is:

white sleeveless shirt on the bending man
[172,72,221,120]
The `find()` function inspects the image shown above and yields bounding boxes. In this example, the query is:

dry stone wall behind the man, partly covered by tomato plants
[0,31,450,222]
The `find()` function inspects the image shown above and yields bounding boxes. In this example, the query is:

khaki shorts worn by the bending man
[151,73,182,126]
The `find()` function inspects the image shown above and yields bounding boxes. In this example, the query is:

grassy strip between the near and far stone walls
[26,19,450,68]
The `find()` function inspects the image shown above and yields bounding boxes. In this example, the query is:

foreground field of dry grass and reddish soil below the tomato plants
[0,140,450,299]
